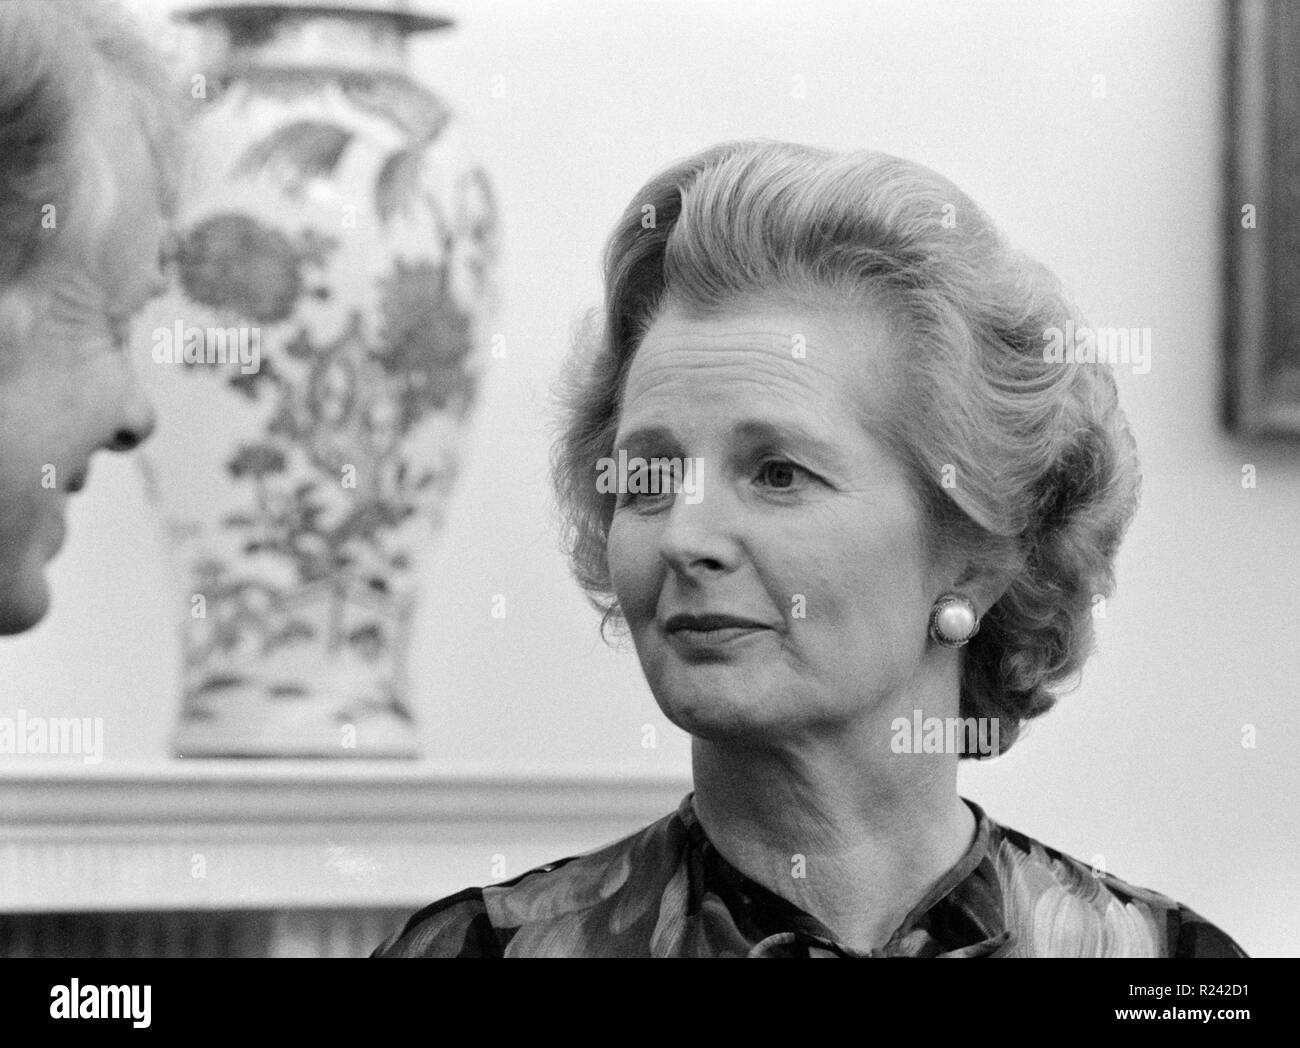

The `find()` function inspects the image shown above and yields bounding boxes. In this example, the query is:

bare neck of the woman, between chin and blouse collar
[692,707,975,950]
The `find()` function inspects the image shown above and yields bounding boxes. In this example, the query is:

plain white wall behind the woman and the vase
[0,0,1300,954]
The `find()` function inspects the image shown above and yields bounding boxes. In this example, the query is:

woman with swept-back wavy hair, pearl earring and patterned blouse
[377,143,1244,957]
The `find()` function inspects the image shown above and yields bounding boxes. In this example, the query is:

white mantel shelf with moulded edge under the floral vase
[0,761,690,913]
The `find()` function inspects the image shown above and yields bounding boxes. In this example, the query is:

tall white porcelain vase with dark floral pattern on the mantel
[137,0,497,757]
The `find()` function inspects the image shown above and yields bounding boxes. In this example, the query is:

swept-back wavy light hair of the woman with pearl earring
[551,142,1140,757]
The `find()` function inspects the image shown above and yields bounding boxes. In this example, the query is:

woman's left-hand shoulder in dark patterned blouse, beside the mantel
[372,813,685,957]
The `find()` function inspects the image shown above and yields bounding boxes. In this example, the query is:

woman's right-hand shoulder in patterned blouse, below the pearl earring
[988,823,1247,957]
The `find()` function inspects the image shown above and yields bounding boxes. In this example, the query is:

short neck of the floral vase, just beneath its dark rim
[203,12,407,73]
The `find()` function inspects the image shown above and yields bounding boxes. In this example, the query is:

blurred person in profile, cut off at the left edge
[0,0,174,635]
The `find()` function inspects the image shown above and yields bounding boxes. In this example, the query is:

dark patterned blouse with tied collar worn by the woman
[373,793,1245,957]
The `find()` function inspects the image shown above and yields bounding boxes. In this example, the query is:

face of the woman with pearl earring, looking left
[608,303,943,741]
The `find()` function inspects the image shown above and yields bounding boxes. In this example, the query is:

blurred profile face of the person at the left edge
[0,113,163,635]
